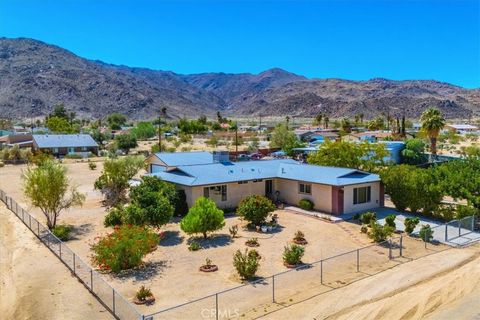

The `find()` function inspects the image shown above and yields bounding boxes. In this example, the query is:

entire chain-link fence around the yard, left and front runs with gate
[0,190,475,320]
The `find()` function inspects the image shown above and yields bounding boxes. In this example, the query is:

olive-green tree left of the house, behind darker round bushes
[95,157,144,207]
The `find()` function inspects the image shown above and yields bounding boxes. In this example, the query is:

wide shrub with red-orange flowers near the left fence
[92,225,159,272]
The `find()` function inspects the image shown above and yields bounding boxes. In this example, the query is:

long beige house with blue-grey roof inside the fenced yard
[147,152,384,215]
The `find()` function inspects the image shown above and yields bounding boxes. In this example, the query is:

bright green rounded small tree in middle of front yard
[180,197,225,239]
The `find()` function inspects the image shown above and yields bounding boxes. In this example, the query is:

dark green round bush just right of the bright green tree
[237,195,275,226]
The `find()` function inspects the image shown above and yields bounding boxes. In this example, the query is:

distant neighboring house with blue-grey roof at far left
[33,134,98,157]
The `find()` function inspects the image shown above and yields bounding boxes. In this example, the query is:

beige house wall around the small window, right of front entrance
[274,179,332,213]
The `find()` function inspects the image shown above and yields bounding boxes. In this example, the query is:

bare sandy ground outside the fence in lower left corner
[0,203,113,320]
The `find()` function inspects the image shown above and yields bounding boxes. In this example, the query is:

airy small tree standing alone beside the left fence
[23,161,85,229]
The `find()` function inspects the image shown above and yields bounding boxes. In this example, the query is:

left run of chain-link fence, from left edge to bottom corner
[0,190,144,320]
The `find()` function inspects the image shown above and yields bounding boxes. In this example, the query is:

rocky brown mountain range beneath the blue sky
[0,38,480,119]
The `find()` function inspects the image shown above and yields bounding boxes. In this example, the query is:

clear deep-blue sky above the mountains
[0,0,480,88]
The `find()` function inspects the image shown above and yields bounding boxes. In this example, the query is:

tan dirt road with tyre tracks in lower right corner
[262,245,480,320]
